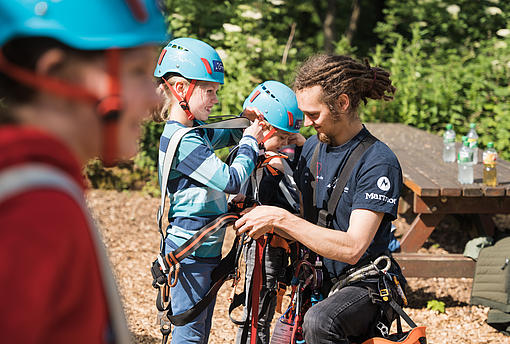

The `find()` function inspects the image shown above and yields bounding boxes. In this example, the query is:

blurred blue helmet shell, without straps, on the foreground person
[0,0,169,50]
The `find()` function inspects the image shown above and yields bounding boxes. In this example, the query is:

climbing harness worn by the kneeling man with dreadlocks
[286,130,426,344]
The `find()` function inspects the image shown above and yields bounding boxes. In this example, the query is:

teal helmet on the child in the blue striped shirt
[154,38,224,84]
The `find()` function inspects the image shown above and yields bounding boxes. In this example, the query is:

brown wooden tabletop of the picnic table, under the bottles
[366,123,510,197]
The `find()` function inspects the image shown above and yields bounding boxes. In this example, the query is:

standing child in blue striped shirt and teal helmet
[154,38,262,344]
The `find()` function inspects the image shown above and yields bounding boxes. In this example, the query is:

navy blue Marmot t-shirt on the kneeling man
[294,127,402,277]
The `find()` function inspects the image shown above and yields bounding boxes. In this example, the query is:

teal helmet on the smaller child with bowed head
[243,80,303,133]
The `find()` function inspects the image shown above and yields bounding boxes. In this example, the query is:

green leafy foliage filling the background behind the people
[88,0,510,189]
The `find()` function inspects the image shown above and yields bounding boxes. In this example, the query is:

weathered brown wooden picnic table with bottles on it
[366,123,510,277]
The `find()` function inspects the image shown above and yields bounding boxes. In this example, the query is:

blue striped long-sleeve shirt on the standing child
[159,121,258,257]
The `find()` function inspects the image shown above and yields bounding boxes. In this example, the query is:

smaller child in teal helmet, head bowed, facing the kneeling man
[236,81,305,344]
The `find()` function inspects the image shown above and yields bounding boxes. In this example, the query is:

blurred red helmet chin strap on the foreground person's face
[0,49,122,166]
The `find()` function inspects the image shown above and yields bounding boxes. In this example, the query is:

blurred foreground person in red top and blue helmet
[0,0,168,344]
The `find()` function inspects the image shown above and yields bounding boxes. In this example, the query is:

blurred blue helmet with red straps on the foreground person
[0,0,168,166]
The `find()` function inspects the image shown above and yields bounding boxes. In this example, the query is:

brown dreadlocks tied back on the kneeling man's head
[294,54,396,113]
